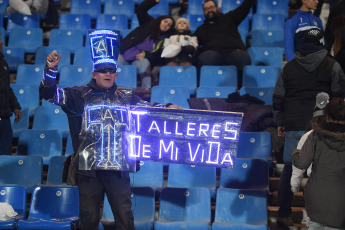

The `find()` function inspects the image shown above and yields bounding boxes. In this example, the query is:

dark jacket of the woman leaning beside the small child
[120,0,169,66]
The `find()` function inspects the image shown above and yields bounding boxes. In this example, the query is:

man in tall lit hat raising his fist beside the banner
[39,30,180,230]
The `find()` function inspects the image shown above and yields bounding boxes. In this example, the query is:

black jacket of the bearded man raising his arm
[194,0,256,52]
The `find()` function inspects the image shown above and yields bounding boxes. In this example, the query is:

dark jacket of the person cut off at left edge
[0,54,21,119]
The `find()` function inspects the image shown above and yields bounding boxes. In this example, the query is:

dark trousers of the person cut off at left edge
[0,118,13,155]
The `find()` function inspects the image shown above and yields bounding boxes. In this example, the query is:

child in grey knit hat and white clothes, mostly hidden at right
[290,93,329,193]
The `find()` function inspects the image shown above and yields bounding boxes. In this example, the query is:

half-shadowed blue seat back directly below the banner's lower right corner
[219,157,269,190]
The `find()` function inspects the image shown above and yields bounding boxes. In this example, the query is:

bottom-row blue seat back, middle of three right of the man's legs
[158,188,211,222]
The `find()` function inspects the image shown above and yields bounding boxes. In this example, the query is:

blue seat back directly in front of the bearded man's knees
[200,65,237,88]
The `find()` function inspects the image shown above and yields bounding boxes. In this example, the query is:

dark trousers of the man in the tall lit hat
[78,170,134,230]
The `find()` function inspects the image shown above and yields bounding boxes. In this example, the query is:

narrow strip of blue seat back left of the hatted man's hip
[46,156,66,185]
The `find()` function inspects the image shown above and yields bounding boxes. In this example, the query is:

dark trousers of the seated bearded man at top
[198,49,251,88]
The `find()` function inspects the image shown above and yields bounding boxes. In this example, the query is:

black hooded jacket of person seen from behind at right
[273,49,345,131]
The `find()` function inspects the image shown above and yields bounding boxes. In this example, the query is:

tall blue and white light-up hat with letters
[89,30,120,71]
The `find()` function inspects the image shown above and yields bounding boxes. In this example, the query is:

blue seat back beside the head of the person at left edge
[2,47,25,71]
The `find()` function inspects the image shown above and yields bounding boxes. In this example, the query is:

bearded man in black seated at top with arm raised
[194,0,256,87]
